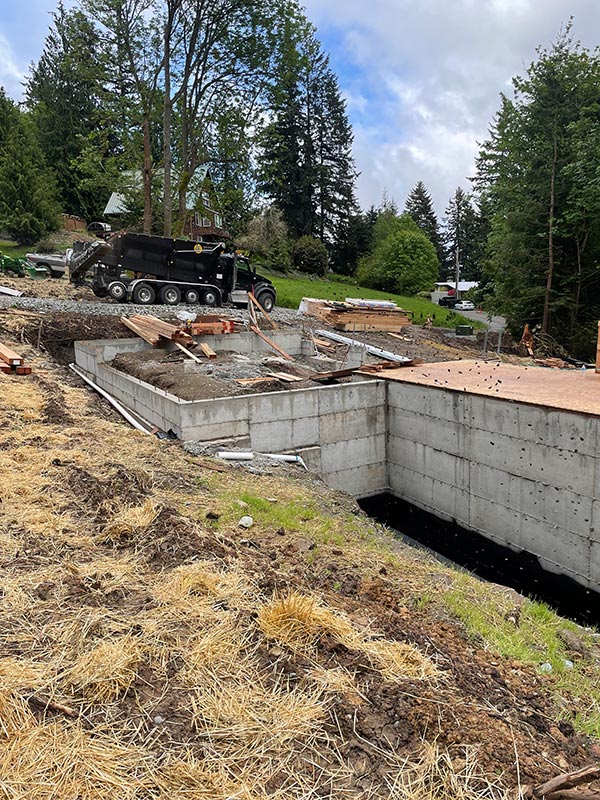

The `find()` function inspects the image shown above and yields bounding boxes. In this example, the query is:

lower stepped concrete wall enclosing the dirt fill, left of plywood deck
[75,331,387,497]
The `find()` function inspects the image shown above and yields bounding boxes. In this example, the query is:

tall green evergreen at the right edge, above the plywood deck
[476,26,600,357]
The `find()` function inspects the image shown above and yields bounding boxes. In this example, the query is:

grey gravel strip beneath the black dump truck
[0,295,303,325]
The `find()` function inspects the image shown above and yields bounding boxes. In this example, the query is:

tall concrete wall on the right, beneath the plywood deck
[387,383,600,591]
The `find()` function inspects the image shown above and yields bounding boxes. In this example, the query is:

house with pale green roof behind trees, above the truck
[104,165,230,242]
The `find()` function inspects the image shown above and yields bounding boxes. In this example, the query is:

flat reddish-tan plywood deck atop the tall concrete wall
[377,360,600,416]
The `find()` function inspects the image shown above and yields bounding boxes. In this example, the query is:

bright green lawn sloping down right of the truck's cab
[259,267,485,328]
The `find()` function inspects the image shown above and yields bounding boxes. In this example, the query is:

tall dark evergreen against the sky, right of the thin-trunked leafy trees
[259,3,356,247]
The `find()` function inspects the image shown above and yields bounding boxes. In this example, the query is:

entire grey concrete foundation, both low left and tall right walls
[75,331,600,591]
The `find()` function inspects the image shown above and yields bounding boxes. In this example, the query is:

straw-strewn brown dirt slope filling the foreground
[0,358,586,800]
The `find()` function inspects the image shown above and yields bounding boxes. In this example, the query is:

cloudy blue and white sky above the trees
[0,0,600,215]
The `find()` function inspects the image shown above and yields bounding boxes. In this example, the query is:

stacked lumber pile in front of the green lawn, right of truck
[300,297,412,332]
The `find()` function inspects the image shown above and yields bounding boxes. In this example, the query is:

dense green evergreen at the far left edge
[0,108,60,245]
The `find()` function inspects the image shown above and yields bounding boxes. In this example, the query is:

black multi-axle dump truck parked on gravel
[68,232,277,311]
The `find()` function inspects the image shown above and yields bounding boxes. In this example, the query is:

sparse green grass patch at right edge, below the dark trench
[443,575,600,738]
